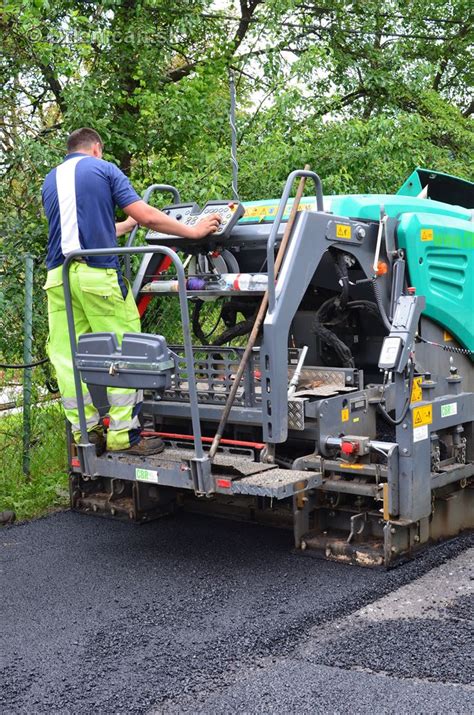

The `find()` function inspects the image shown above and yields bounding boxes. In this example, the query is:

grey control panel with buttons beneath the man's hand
[146,201,245,242]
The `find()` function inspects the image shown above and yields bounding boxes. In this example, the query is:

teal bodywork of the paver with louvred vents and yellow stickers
[240,169,474,350]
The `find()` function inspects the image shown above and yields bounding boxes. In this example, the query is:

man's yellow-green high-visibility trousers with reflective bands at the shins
[44,261,143,450]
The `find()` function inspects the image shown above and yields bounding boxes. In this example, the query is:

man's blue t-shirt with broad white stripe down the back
[42,152,140,270]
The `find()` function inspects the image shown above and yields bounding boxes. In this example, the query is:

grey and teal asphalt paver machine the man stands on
[64,169,474,566]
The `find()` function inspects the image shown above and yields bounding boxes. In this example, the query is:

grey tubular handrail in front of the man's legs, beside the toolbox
[63,246,204,459]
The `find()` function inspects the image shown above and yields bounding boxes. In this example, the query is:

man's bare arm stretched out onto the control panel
[123,201,221,239]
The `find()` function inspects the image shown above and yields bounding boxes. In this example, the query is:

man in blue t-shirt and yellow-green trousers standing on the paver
[42,127,220,456]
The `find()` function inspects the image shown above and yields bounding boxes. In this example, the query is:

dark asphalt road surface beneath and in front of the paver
[0,512,474,715]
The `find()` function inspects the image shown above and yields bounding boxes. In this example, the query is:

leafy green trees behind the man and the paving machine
[0,0,474,513]
